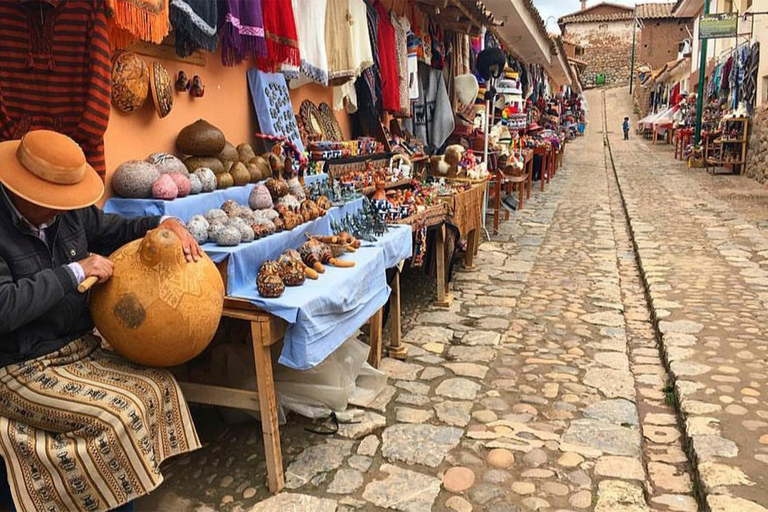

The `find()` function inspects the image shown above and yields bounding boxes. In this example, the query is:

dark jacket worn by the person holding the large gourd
[0,186,160,367]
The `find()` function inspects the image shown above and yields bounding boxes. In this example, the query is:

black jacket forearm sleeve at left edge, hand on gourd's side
[0,258,77,334]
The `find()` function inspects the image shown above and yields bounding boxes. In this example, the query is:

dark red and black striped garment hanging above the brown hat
[0,0,112,178]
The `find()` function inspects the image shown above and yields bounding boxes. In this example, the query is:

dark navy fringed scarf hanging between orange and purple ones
[170,0,219,57]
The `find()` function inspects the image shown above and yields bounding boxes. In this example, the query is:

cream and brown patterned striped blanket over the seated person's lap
[0,335,200,511]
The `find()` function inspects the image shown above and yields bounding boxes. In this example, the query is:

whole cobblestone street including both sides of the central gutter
[137,88,768,512]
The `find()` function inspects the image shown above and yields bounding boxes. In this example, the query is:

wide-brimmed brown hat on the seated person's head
[0,130,104,210]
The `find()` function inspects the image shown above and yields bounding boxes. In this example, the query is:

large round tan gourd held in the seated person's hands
[90,229,224,367]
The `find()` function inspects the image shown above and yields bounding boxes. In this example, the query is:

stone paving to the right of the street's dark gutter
[606,86,768,511]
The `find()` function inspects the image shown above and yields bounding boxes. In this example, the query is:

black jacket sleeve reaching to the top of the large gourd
[80,206,160,256]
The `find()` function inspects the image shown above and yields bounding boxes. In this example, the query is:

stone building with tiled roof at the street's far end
[557,1,634,88]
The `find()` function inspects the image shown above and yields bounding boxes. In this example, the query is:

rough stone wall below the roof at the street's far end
[565,20,632,88]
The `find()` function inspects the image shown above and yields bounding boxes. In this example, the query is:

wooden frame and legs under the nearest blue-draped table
[179,272,384,493]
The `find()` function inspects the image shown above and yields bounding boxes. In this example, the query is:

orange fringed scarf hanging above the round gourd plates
[107,0,171,49]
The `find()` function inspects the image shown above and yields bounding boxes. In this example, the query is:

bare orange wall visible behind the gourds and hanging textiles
[104,53,350,200]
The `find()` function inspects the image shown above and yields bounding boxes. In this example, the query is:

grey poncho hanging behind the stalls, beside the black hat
[405,63,455,154]
